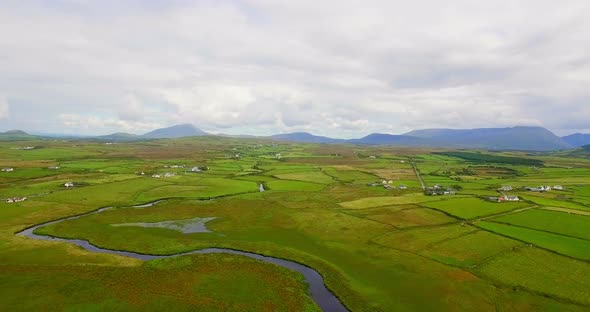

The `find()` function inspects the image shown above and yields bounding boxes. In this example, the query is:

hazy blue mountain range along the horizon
[0,124,590,151]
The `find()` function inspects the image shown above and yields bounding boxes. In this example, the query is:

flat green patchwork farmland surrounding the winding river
[0,136,590,311]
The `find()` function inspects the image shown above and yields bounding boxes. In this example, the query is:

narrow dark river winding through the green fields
[16,200,348,312]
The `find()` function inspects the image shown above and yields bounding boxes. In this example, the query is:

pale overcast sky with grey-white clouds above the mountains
[0,0,590,138]
